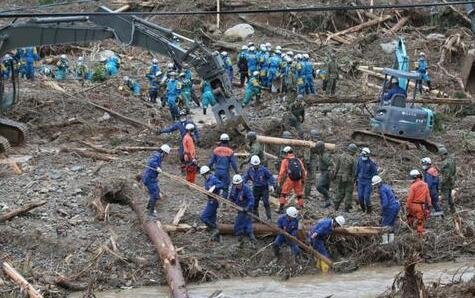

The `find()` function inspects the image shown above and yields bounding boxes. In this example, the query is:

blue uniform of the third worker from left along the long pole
[229,183,254,239]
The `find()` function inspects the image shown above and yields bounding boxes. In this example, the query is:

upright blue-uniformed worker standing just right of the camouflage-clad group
[356,147,378,214]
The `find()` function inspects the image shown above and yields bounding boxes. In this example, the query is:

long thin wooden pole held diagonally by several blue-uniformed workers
[161,172,333,267]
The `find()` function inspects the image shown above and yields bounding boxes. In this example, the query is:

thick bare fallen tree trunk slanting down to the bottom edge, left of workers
[129,200,189,298]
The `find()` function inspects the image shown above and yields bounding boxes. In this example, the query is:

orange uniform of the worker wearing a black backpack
[277,153,307,207]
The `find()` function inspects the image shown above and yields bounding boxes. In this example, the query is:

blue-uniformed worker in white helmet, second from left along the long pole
[200,166,224,242]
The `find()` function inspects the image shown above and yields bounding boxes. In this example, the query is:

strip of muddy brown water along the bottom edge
[70,260,475,298]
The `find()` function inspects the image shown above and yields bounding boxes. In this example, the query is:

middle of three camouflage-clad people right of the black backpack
[315,141,333,208]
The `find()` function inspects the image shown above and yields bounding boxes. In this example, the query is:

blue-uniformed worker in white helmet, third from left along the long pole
[225,174,256,248]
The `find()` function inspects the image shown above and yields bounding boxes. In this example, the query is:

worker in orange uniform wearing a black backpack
[277,146,307,213]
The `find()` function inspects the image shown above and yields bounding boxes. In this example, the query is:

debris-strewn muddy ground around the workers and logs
[0,1,475,297]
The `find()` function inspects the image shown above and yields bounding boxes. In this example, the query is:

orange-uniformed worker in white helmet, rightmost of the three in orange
[407,170,432,235]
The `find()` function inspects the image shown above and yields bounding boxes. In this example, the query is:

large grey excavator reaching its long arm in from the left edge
[0,6,249,152]
